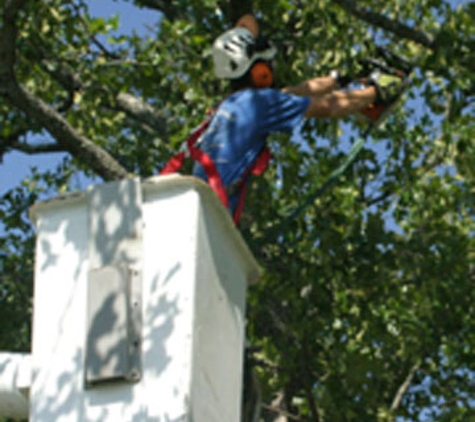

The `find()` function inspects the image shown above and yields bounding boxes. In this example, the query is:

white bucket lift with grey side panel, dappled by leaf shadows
[0,175,259,422]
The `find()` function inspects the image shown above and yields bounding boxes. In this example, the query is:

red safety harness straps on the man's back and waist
[160,108,271,224]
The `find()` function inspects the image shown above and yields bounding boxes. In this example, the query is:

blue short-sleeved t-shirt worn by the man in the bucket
[193,88,310,212]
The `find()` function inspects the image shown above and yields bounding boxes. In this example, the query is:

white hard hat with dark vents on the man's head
[213,28,277,79]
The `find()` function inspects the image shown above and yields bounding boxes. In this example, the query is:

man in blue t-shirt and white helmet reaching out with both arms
[193,15,402,221]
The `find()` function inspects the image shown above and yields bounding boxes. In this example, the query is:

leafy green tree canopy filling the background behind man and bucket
[0,0,475,422]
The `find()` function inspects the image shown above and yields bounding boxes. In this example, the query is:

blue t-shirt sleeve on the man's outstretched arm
[259,88,310,135]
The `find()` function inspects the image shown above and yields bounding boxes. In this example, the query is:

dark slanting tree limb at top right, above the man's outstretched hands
[333,0,436,50]
